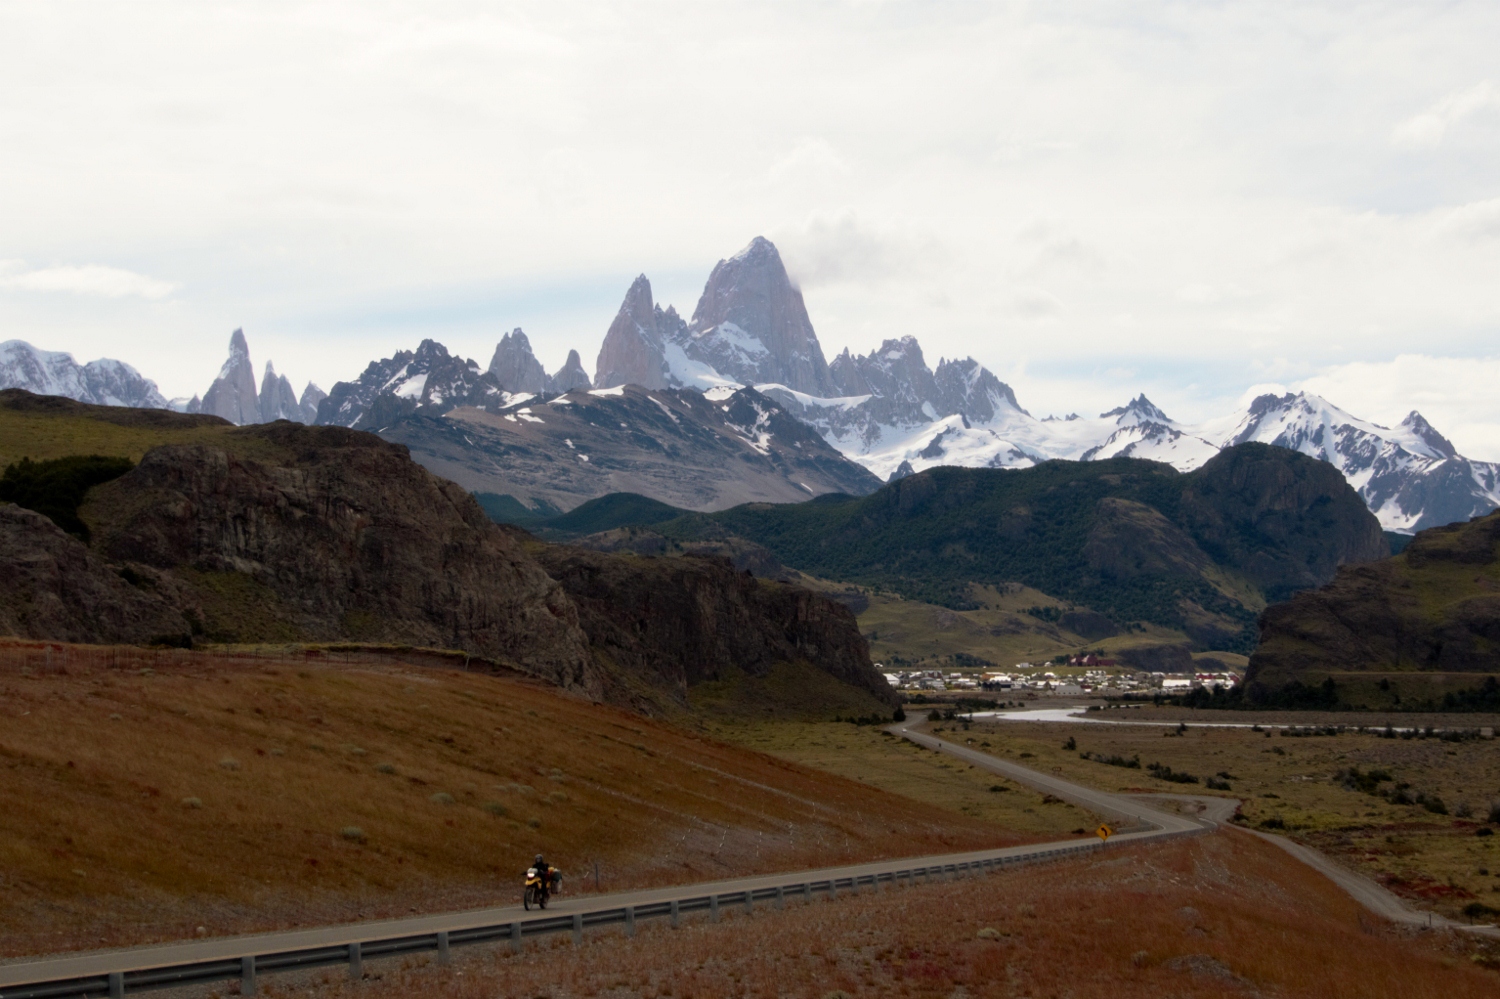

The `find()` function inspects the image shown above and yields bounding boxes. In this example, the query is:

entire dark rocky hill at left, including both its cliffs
[0,393,890,713]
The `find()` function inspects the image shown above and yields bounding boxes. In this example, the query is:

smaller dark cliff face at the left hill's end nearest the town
[537,546,900,708]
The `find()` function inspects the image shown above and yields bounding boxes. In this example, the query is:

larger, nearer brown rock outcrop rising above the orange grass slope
[86,423,602,696]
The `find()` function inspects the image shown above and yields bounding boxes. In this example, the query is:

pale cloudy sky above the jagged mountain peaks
[0,0,1500,461]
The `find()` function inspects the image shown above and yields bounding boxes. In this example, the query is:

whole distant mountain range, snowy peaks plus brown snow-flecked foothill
[0,237,1500,534]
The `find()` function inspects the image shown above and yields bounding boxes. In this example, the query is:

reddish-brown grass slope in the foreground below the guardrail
[279,833,1500,999]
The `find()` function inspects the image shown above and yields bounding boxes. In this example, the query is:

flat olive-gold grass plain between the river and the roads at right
[933,708,1500,917]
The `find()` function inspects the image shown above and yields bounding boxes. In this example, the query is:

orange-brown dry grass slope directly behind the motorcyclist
[0,642,1037,956]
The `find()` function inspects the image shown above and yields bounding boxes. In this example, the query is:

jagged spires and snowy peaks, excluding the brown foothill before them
[8,237,1500,533]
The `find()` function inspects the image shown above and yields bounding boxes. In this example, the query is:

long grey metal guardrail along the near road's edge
[0,830,1188,999]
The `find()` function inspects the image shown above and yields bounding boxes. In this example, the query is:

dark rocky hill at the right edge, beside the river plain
[1247,512,1500,699]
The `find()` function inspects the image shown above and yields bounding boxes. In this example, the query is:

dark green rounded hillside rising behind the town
[567,444,1389,651]
